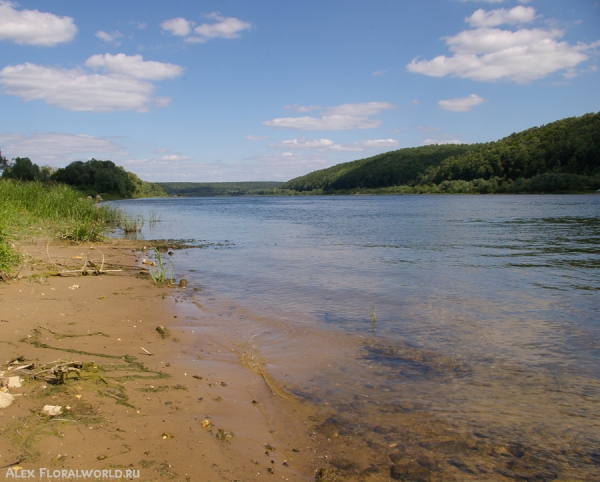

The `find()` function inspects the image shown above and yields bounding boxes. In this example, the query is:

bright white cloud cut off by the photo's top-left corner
[0,1,77,47]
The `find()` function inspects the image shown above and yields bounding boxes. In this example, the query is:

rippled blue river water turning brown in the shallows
[113,195,600,481]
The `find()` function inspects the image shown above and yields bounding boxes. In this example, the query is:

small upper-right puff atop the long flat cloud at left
[85,54,184,80]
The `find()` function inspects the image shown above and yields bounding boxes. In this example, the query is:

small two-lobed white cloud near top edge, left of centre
[160,13,252,43]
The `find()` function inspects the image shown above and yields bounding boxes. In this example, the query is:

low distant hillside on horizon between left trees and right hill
[158,181,283,197]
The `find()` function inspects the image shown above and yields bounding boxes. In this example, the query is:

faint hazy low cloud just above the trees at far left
[0,132,126,167]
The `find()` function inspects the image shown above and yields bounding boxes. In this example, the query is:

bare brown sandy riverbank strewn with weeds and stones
[0,240,320,481]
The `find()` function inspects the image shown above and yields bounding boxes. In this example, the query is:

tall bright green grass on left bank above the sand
[0,179,119,271]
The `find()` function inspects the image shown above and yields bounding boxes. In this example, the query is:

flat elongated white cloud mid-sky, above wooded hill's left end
[263,102,396,130]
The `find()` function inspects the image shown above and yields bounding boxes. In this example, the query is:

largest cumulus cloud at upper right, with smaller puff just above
[407,7,598,83]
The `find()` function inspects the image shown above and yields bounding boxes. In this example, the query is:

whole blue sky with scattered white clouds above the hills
[0,0,600,182]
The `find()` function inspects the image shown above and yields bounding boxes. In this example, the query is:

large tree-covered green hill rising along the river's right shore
[281,113,600,194]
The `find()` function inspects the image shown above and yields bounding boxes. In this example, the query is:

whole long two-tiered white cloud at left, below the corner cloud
[0,54,183,112]
